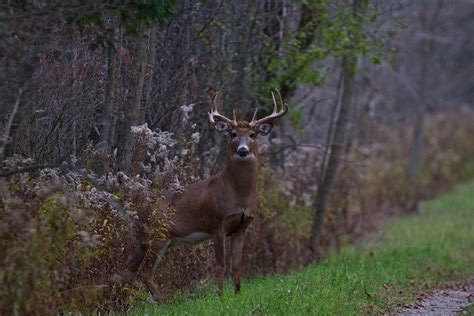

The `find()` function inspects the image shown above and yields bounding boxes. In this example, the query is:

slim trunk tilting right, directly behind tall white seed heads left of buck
[121,27,148,171]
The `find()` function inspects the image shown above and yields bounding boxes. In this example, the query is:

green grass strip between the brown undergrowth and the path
[131,183,474,315]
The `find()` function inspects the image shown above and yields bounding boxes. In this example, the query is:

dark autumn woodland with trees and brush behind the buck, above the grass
[0,0,474,314]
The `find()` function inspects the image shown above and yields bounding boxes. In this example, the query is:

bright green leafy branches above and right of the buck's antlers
[255,0,383,100]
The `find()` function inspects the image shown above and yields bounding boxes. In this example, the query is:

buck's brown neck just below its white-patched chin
[222,157,258,198]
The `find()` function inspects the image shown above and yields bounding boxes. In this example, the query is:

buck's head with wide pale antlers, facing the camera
[209,91,288,160]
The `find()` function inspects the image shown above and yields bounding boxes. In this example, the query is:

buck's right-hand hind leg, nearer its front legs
[141,240,171,301]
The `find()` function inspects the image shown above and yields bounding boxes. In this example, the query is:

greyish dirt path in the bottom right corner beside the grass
[396,280,474,316]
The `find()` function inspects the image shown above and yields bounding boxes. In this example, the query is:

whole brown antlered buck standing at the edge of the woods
[116,91,288,302]
